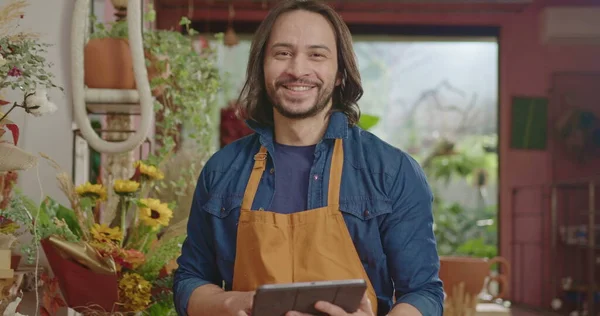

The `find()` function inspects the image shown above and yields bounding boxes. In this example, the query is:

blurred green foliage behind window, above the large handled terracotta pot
[425,136,498,257]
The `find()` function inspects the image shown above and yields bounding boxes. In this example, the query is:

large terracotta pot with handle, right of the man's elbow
[440,257,510,299]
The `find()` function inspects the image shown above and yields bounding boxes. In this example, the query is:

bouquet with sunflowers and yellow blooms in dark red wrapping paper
[37,161,184,315]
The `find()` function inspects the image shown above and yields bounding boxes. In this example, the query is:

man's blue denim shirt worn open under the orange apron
[173,112,443,316]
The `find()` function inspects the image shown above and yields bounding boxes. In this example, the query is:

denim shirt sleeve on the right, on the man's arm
[381,155,444,316]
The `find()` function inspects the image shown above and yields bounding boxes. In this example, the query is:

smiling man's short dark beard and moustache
[267,79,334,120]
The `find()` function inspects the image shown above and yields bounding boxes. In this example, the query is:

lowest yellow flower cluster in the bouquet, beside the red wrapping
[119,273,152,312]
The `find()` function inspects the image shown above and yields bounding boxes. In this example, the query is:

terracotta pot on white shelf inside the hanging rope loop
[83,38,135,89]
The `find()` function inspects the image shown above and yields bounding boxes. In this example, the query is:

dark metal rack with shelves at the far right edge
[550,178,600,316]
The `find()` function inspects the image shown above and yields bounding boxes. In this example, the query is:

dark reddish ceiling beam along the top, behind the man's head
[156,0,531,28]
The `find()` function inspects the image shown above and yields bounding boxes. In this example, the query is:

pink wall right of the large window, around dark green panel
[499,0,600,308]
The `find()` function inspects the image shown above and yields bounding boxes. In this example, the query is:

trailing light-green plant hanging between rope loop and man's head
[144,25,220,164]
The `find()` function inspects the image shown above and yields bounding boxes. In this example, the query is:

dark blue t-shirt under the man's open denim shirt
[269,143,316,214]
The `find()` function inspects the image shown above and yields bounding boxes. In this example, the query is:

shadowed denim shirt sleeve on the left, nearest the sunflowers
[173,170,220,315]
